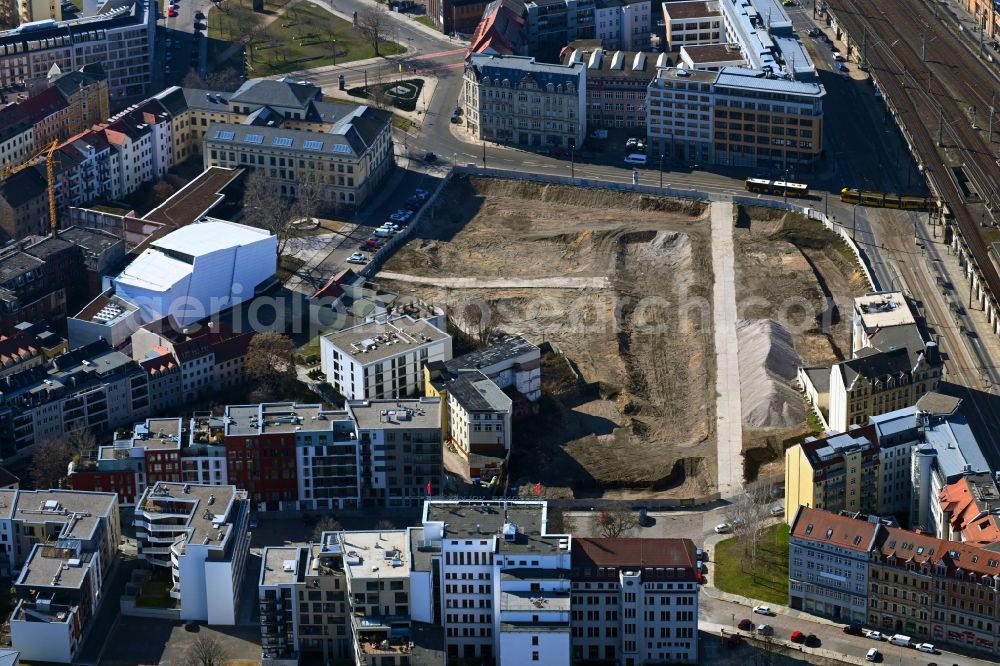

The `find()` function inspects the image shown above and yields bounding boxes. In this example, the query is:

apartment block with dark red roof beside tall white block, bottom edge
[572,538,699,666]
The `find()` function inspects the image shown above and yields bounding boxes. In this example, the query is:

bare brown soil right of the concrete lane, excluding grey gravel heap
[734,208,868,476]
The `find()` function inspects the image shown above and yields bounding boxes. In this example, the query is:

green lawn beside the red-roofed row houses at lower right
[713,523,788,605]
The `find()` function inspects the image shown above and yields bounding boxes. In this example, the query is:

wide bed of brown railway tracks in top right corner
[829,0,1000,324]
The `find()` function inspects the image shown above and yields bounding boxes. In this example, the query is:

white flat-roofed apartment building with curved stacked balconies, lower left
[135,481,250,625]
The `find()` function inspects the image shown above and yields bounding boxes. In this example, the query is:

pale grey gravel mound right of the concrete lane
[736,319,806,428]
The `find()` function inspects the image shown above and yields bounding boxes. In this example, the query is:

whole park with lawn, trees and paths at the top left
[207,0,404,77]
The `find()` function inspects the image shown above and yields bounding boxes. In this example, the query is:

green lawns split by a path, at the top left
[208,3,404,77]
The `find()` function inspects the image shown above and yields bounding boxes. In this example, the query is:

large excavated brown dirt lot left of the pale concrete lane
[383,178,716,497]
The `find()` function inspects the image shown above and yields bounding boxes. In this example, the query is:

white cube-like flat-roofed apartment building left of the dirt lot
[320,315,451,400]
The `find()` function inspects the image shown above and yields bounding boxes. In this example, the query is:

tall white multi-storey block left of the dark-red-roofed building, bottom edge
[412,501,571,666]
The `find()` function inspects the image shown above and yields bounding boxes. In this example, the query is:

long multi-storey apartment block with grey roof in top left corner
[0,0,156,104]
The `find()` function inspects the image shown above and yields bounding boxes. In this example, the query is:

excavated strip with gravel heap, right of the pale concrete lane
[734,206,871,475]
